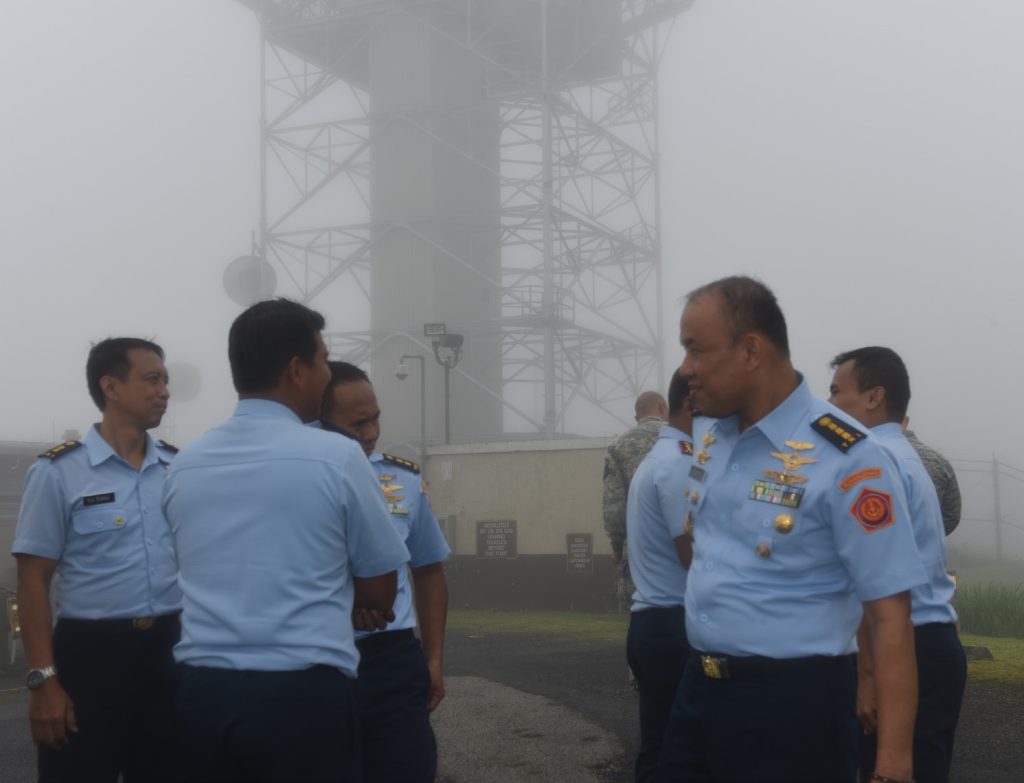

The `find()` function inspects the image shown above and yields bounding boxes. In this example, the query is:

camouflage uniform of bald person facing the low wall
[604,416,666,611]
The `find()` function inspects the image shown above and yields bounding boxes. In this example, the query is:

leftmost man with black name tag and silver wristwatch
[11,338,181,783]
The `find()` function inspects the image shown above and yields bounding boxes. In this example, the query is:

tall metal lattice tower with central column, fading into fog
[242,0,691,440]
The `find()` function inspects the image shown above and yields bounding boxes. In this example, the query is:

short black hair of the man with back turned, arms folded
[227,298,325,394]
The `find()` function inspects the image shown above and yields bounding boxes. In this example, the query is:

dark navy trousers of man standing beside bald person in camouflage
[626,606,690,783]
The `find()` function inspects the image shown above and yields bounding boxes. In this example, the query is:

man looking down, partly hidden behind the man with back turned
[322,361,451,783]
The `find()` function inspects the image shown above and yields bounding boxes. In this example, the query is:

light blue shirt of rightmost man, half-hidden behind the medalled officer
[871,423,956,625]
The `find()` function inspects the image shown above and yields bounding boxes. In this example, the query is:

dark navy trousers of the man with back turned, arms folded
[177,665,362,783]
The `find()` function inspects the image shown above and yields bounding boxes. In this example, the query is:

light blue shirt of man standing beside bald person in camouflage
[626,426,692,612]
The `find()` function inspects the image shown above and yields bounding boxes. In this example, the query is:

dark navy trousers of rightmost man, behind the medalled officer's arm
[860,622,967,783]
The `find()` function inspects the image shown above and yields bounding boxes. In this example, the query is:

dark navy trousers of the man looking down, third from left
[355,629,437,783]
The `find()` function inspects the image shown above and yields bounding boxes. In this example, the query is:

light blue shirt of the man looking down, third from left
[355,454,452,639]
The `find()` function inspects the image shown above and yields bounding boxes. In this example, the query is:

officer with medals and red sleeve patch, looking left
[658,277,925,783]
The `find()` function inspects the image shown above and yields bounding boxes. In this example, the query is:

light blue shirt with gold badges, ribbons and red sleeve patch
[686,379,927,658]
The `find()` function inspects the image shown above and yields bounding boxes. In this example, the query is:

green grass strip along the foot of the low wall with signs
[447,609,629,642]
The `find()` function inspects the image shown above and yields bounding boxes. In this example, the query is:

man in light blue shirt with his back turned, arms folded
[164,299,409,781]
